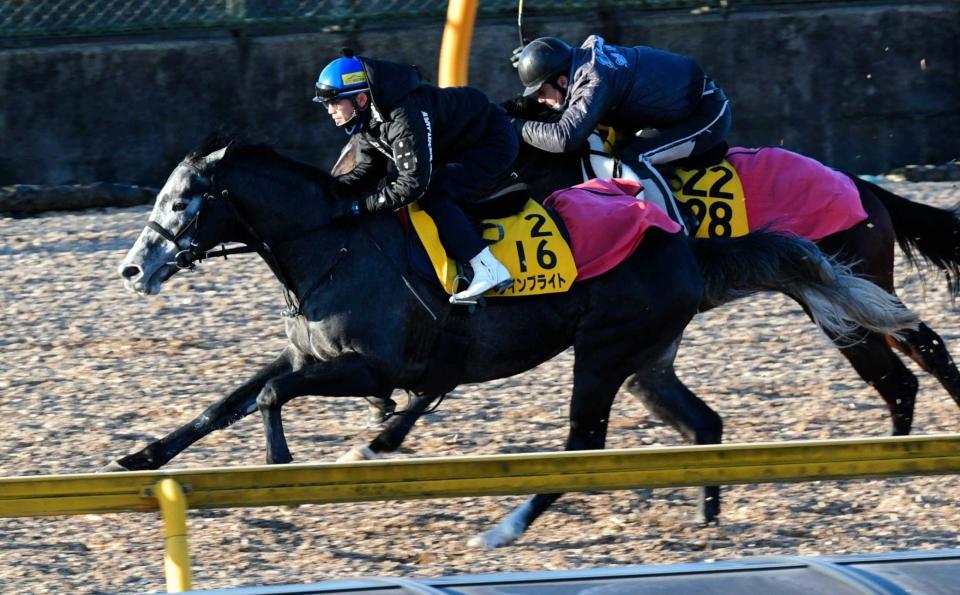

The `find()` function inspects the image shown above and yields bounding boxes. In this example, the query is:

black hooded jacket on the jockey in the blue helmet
[338,58,506,212]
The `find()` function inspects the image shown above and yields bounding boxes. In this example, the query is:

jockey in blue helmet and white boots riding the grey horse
[314,49,519,303]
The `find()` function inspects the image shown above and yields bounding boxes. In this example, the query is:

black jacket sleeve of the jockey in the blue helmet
[361,99,433,213]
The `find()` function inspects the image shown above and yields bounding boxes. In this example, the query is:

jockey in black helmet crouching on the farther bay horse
[514,35,731,225]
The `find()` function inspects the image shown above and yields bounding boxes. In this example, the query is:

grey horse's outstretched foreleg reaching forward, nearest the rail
[101,351,292,471]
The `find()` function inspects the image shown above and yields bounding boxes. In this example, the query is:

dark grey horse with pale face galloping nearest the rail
[114,139,915,545]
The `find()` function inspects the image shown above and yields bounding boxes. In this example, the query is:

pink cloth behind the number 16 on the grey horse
[543,178,680,281]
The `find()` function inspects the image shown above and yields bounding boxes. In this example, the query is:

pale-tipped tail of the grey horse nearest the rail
[691,231,919,337]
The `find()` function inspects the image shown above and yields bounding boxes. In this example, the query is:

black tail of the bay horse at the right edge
[851,176,960,296]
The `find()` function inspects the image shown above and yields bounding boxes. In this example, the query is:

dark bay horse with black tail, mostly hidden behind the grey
[518,145,960,428]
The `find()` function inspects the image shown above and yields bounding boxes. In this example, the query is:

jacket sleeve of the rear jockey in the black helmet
[522,71,610,153]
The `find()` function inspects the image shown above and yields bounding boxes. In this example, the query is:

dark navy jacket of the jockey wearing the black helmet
[523,35,706,153]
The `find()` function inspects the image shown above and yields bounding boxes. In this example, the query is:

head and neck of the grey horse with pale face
[118,135,344,294]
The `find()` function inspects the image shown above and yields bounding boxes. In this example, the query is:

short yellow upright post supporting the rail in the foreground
[154,477,193,593]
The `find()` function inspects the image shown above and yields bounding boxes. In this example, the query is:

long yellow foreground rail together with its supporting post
[0,434,960,591]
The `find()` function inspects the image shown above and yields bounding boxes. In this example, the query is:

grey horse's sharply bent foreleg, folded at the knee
[256,355,389,464]
